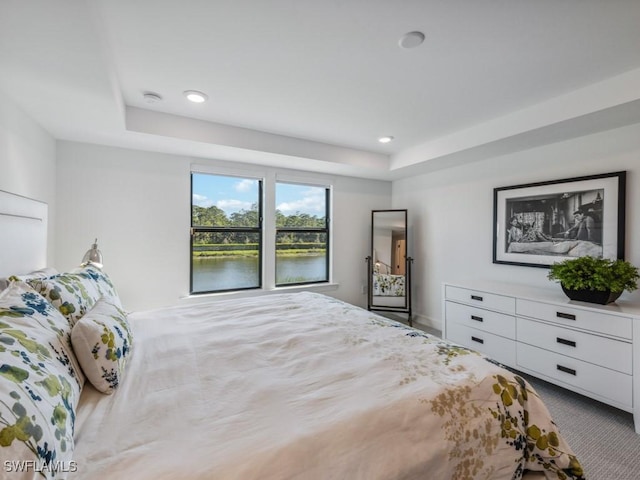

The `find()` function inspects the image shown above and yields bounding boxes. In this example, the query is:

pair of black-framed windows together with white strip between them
[189,169,331,294]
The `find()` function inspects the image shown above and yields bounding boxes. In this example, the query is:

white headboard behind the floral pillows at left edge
[0,190,48,277]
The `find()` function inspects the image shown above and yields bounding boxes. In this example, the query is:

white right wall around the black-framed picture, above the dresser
[393,125,640,327]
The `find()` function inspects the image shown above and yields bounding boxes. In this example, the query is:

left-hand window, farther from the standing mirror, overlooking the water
[190,173,263,293]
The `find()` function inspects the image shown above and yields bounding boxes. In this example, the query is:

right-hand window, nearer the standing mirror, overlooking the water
[275,182,329,286]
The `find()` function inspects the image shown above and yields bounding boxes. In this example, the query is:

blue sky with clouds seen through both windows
[193,174,325,216]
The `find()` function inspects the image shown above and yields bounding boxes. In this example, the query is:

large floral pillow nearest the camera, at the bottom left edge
[0,281,84,479]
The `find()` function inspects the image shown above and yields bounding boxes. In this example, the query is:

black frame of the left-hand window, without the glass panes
[189,169,265,295]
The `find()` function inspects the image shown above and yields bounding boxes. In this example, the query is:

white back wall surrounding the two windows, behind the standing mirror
[55,141,391,310]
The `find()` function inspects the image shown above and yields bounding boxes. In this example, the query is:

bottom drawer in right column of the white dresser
[517,343,633,408]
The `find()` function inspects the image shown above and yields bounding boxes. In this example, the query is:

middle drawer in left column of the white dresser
[445,302,516,340]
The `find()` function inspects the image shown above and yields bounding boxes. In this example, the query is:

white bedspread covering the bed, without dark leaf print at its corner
[69,293,579,480]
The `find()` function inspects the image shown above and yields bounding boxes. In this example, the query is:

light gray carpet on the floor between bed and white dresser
[414,323,640,480]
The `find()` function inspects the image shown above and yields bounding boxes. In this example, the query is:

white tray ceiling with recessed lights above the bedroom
[0,0,640,179]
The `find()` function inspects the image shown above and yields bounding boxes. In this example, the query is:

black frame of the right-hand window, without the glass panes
[273,179,331,288]
